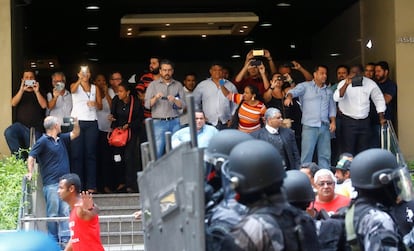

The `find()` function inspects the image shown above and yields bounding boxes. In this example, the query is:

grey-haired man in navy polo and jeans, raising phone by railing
[26,116,80,243]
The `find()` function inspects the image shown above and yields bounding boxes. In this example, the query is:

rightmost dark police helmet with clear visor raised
[350,148,413,201]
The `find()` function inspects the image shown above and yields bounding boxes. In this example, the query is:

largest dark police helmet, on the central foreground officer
[227,140,286,195]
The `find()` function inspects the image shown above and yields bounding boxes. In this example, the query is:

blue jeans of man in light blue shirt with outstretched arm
[300,124,331,169]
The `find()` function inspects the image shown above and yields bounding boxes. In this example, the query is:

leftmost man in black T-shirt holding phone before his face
[4,70,47,158]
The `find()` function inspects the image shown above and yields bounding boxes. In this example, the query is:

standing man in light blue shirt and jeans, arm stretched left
[284,65,336,169]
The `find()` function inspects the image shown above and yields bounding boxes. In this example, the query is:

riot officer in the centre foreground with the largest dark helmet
[220,140,317,251]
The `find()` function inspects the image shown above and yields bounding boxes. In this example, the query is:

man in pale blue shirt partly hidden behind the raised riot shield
[171,111,218,148]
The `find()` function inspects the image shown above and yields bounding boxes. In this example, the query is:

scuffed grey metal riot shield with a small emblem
[138,142,205,251]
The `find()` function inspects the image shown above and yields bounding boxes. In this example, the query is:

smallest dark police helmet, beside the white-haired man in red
[283,170,315,203]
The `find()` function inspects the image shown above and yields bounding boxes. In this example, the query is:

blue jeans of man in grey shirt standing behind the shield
[153,118,180,158]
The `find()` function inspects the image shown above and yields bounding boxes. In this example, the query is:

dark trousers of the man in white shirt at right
[341,115,371,156]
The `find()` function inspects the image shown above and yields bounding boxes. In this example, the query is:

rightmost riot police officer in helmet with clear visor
[345,149,412,251]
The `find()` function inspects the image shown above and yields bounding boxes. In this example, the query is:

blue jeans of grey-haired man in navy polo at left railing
[43,183,70,243]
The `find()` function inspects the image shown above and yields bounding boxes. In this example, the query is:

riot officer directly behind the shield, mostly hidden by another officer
[204,129,253,251]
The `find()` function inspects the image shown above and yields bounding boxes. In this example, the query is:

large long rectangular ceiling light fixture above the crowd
[120,12,259,37]
